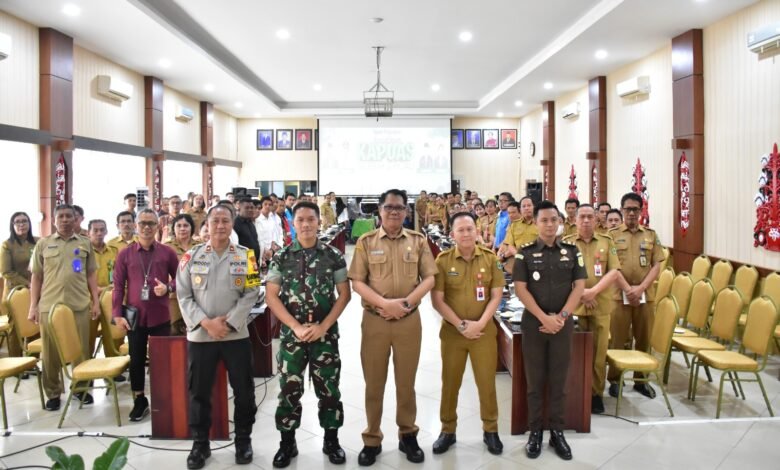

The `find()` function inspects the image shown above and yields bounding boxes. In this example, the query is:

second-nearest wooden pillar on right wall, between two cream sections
[583,76,608,206]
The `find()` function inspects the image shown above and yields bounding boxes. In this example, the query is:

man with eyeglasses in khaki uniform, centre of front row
[348,189,437,466]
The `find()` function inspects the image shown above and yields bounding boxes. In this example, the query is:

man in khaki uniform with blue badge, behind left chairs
[27,204,100,411]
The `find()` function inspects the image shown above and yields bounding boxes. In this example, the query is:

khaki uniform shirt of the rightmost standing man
[609,224,665,302]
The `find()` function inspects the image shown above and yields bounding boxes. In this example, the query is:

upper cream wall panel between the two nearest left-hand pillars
[73,46,144,146]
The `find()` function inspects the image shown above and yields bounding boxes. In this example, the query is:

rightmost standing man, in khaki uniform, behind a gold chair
[607,193,665,398]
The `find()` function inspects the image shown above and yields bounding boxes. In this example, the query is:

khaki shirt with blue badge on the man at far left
[32,233,97,313]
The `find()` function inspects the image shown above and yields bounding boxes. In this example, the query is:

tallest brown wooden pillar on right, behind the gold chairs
[672,29,704,272]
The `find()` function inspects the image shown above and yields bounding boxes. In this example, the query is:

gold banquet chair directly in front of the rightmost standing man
[607,296,677,417]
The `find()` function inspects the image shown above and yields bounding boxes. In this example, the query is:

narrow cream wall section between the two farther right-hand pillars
[555,85,590,208]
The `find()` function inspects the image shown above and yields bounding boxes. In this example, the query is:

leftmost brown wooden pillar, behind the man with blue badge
[38,28,73,236]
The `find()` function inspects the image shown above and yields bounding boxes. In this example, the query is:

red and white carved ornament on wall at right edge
[753,143,780,251]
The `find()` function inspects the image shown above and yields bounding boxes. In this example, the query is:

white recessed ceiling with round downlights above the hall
[0,0,756,118]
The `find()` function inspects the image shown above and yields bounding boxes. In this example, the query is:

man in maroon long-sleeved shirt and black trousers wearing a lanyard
[111,209,179,421]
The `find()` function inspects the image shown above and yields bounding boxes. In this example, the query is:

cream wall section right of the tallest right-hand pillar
[704,1,780,269]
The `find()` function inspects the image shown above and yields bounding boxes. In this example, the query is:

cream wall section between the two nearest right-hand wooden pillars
[607,44,674,246]
